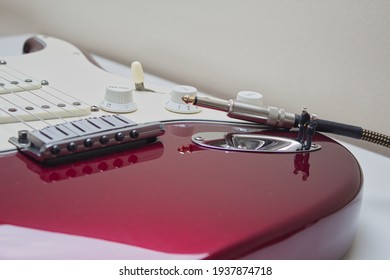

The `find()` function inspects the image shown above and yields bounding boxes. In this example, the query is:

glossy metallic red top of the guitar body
[0,122,362,258]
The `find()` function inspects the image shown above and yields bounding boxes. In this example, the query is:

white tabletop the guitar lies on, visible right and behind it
[0,36,390,259]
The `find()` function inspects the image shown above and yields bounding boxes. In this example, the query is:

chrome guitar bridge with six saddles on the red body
[9,115,164,162]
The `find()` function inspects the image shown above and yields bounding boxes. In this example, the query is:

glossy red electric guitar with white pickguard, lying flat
[0,36,363,259]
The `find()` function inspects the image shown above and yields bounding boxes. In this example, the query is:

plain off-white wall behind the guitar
[0,0,390,153]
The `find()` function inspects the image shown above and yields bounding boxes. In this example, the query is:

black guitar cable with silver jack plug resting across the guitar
[182,95,390,148]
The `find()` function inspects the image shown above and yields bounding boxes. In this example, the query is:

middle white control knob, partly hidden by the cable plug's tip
[165,86,202,114]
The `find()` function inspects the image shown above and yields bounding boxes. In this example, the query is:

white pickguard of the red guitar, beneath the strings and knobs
[0,35,228,153]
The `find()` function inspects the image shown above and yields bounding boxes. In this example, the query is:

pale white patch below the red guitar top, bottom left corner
[0,225,206,260]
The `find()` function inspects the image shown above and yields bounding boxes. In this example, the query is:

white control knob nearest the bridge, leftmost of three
[100,85,137,113]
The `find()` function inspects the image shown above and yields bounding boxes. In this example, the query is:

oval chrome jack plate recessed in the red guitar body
[192,132,321,153]
